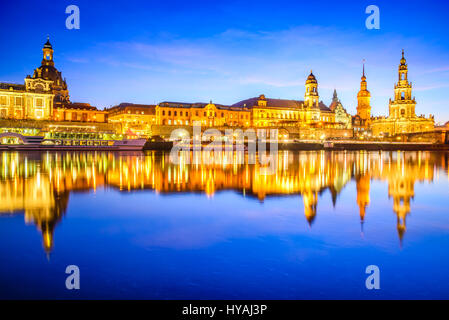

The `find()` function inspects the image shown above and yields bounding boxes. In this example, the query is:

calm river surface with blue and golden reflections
[0,152,449,299]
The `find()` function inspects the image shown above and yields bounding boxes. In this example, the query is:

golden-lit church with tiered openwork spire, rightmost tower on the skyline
[371,50,434,137]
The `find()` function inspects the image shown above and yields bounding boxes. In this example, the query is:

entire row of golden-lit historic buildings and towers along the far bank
[0,39,434,140]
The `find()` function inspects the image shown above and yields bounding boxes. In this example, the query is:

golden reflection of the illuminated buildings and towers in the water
[0,151,442,252]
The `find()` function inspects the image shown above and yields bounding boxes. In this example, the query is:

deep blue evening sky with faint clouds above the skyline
[0,0,449,122]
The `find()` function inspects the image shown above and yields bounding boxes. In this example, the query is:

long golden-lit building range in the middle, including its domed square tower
[155,72,351,129]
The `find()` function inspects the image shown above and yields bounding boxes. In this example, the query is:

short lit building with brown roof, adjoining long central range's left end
[107,103,157,136]
